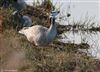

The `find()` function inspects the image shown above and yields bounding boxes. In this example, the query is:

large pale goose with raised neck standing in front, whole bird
[19,11,59,46]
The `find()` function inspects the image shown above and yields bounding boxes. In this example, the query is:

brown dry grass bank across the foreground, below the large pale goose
[0,29,100,72]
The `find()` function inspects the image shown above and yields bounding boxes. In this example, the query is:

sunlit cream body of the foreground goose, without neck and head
[19,25,53,46]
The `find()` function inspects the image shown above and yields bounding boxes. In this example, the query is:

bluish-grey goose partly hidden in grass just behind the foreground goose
[13,12,32,28]
